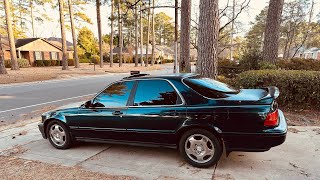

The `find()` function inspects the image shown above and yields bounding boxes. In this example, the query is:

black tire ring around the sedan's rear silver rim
[179,129,223,168]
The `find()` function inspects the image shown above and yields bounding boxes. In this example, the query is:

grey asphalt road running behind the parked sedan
[0,67,172,124]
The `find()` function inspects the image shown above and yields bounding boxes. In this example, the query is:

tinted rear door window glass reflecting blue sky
[133,80,182,106]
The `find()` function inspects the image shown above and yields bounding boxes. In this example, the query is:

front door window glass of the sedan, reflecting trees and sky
[93,81,134,107]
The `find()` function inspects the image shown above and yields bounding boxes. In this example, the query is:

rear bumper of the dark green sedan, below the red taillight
[223,110,288,152]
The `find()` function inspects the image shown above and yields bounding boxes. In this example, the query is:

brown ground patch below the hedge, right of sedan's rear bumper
[284,110,320,126]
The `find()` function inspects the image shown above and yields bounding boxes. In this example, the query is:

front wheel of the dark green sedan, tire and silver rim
[46,120,72,149]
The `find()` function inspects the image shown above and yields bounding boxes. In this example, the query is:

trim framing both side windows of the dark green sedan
[87,78,186,109]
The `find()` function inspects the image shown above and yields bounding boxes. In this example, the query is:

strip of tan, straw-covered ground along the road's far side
[0,63,164,84]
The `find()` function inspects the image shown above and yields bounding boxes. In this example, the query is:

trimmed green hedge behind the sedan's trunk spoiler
[232,70,320,109]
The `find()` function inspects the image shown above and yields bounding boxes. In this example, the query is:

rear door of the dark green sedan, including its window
[125,79,186,144]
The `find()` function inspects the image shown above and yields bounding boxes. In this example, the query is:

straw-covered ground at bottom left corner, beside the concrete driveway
[0,156,137,180]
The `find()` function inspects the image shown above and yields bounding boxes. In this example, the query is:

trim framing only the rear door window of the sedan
[128,78,185,108]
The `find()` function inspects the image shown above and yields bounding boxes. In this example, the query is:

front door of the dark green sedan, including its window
[69,81,134,140]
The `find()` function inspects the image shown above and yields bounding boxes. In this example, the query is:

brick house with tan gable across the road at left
[1,38,73,66]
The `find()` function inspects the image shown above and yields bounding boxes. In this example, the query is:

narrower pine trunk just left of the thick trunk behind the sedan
[179,0,191,72]
